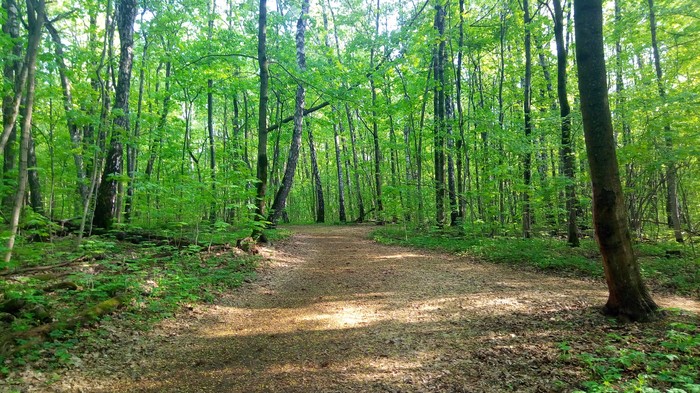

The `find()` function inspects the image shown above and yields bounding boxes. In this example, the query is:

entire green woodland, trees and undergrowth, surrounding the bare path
[0,0,700,391]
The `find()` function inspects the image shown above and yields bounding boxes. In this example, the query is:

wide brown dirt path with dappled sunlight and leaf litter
[10,225,700,393]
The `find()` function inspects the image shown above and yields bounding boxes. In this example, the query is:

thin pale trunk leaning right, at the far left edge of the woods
[5,0,45,263]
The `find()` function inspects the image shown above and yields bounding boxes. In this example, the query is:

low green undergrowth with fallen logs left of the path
[0,228,288,378]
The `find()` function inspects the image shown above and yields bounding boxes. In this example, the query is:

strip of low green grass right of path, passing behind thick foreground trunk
[372,226,700,297]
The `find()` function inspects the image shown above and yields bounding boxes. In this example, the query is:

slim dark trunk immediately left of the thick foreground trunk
[554,0,579,247]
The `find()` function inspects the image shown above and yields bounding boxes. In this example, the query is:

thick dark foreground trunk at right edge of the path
[574,0,657,321]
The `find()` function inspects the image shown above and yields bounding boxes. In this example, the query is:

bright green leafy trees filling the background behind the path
[0,0,700,272]
